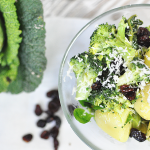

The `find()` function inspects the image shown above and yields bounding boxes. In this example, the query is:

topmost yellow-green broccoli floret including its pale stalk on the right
[89,17,138,66]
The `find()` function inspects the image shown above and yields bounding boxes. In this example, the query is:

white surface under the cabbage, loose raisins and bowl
[0,17,90,150]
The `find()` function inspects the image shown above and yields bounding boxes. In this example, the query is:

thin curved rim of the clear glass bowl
[58,4,150,150]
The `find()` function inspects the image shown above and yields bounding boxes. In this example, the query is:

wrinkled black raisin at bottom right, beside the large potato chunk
[130,128,146,142]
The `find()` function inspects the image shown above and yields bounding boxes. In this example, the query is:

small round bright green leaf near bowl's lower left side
[73,108,94,124]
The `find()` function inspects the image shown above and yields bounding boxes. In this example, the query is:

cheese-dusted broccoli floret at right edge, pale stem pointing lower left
[117,57,150,86]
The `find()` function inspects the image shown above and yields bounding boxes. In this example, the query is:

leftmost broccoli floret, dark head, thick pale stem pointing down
[70,52,104,100]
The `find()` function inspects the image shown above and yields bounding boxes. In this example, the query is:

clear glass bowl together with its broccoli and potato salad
[59,4,150,150]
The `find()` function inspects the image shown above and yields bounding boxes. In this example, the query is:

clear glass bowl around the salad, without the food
[58,4,150,150]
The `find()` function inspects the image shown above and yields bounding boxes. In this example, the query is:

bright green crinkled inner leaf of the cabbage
[0,0,22,92]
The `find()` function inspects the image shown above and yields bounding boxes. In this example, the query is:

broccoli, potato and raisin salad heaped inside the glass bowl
[69,15,150,142]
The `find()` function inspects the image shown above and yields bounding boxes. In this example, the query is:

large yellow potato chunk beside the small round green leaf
[95,108,132,142]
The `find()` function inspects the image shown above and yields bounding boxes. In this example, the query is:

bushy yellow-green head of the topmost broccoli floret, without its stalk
[89,23,116,54]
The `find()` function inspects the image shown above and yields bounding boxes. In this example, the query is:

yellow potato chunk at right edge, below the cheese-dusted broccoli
[134,83,150,120]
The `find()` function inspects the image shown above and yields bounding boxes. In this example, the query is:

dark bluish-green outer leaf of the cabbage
[8,0,46,93]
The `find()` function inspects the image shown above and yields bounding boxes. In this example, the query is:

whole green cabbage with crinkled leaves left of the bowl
[0,0,46,94]
